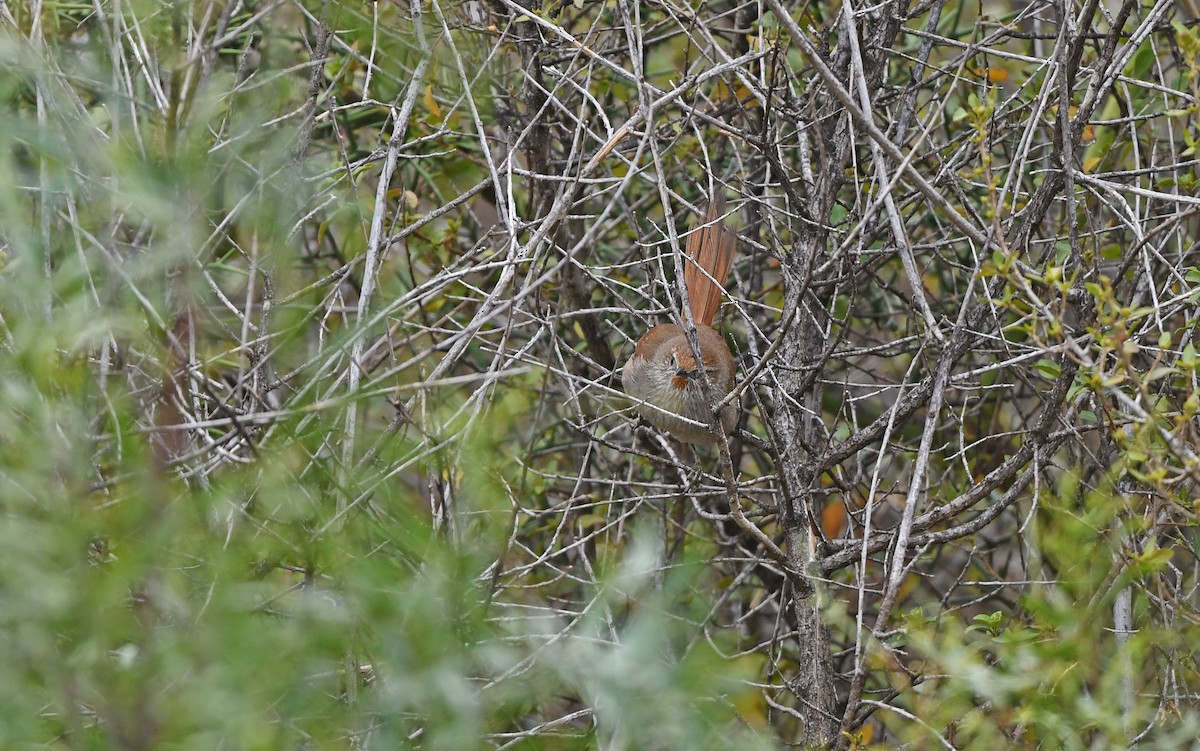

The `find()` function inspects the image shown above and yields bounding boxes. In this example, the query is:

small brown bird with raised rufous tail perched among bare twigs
[620,197,738,444]
